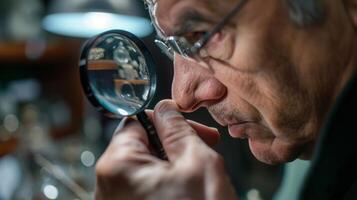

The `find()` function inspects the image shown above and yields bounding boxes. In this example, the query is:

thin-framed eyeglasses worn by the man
[149,0,247,60]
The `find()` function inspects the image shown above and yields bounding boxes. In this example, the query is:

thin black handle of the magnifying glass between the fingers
[136,111,168,160]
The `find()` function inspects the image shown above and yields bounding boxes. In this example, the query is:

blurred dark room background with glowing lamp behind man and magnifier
[0,0,282,200]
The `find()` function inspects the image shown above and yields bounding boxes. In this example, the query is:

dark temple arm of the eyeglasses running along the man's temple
[190,0,247,54]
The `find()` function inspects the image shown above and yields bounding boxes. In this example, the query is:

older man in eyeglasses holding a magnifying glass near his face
[96,0,357,199]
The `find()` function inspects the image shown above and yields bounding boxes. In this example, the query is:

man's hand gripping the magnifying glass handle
[96,100,236,200]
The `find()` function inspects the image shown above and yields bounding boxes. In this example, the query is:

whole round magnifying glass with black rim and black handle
[79,30,167,160]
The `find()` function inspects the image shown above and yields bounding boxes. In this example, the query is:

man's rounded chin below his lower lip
[248,139,301,165]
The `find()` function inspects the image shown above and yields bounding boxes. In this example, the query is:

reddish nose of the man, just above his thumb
[172,55,227,112]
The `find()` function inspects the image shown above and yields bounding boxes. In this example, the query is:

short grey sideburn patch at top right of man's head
[287,0,325,26]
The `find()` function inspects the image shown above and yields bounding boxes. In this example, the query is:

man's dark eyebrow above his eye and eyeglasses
[172,10,212,36]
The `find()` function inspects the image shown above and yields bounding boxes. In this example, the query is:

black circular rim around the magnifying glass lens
[79,30,157,118]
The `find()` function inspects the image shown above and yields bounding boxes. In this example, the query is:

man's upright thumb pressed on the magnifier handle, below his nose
[153,100,209,160]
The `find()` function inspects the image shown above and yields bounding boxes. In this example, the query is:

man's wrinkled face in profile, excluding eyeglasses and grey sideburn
[154,0,354,163]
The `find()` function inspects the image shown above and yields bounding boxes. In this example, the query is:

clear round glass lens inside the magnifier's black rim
[87,33,151,116]
